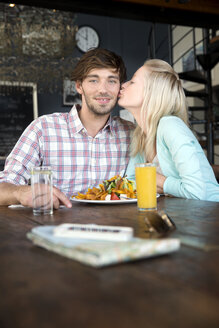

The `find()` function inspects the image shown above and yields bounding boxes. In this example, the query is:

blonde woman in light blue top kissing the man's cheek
[119,59,219,201]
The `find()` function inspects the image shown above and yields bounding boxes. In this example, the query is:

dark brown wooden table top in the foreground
[0,197,219,328]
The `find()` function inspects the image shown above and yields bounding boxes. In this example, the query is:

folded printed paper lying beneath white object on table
[27,226,180,268]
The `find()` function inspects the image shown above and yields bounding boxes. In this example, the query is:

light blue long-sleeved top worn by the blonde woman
[126,116,219,202]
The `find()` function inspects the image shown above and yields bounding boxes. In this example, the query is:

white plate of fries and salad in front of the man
[71,175,137,205]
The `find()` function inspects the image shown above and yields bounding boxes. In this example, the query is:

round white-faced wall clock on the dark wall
[75,26,100,52]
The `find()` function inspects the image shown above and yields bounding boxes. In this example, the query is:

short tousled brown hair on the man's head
[72,48,126,83]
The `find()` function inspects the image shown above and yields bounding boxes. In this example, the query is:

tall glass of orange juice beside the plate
[135,163,157,211]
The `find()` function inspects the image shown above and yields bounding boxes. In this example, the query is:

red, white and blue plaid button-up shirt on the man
[0,106,134,196]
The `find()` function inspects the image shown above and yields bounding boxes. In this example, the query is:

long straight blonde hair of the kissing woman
[131,59,188,161]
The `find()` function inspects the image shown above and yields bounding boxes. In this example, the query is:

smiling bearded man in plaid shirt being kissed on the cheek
[0,49,133,208]
